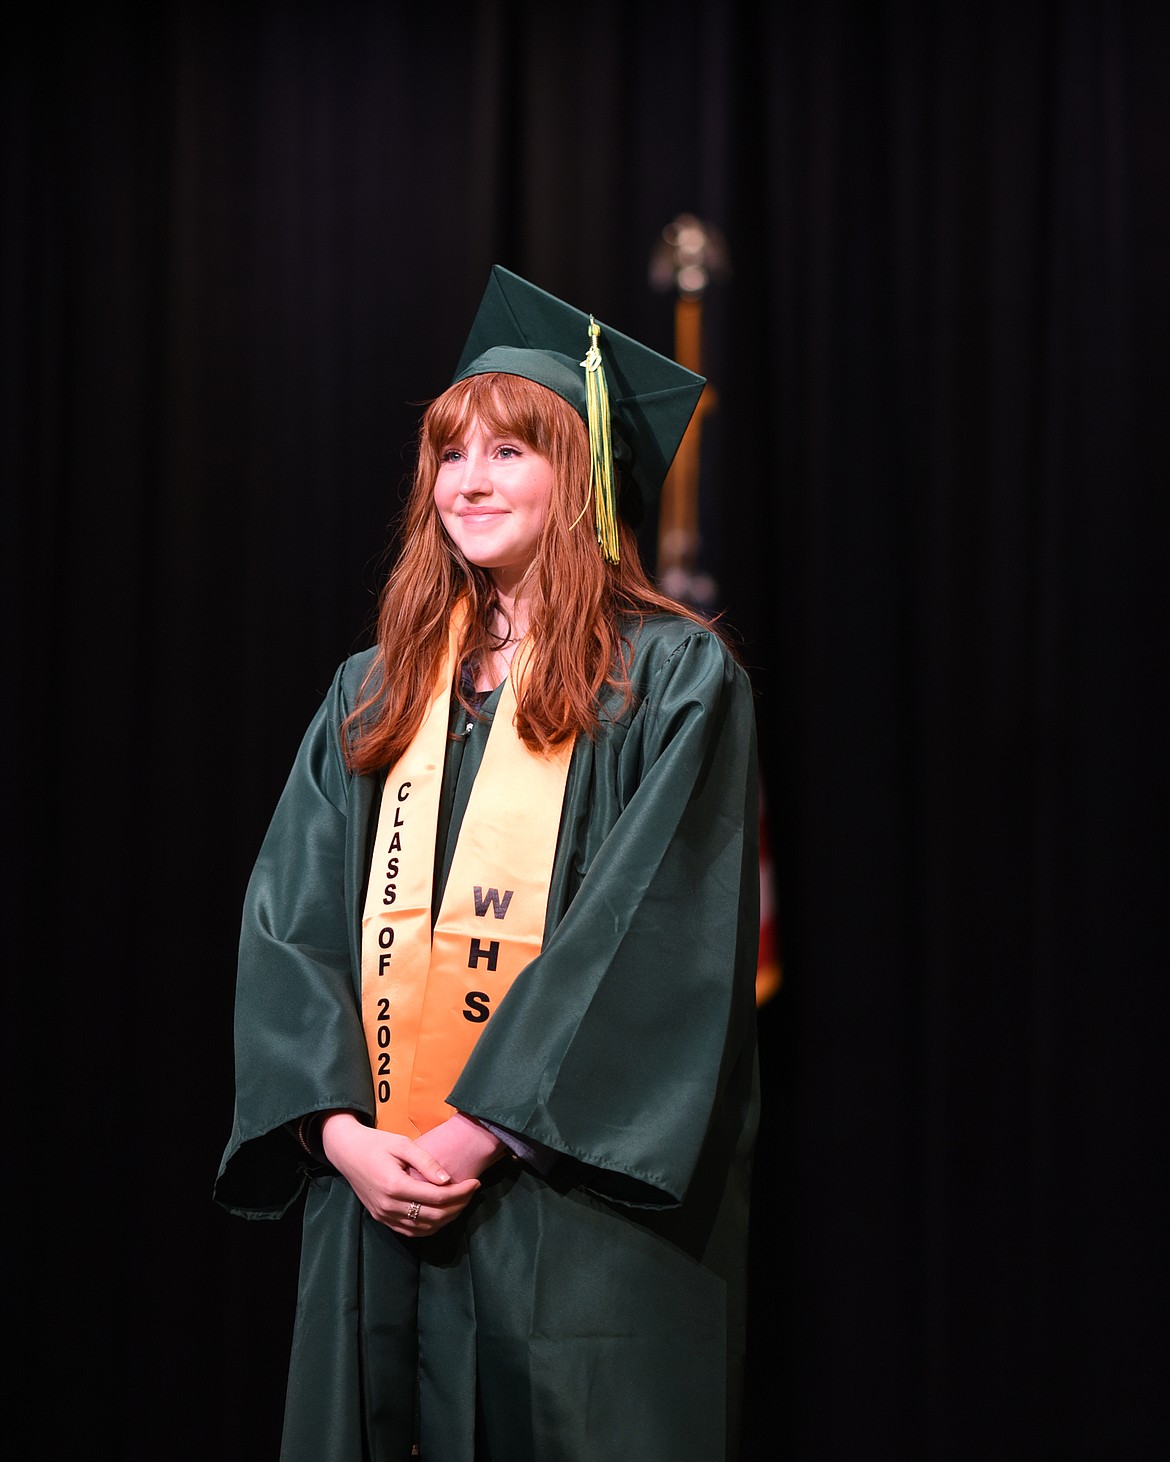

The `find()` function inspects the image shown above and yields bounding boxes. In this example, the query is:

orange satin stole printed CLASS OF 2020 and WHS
[361,614,572,1137]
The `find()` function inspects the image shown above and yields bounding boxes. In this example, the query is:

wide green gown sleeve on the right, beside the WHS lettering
[449,630,759,1206]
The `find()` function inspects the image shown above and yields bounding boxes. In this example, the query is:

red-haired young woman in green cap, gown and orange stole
[216,268,759,1462]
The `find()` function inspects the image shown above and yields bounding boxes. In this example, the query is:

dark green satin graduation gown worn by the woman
[215,616,759,1462]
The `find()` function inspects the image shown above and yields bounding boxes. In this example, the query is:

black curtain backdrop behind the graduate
[0,0,1170,1462]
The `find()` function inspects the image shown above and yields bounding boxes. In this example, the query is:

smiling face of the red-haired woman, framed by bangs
[434,417,553,594]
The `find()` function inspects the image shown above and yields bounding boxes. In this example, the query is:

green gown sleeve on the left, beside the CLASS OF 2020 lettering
[215,661,373,1218]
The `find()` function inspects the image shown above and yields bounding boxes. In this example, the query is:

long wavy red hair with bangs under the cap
[342,373,708,772]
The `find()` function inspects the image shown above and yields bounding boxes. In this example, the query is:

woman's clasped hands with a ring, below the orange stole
[320,1111,505,1238]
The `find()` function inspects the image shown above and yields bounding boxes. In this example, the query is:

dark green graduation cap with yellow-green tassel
[452,265,705,563]
